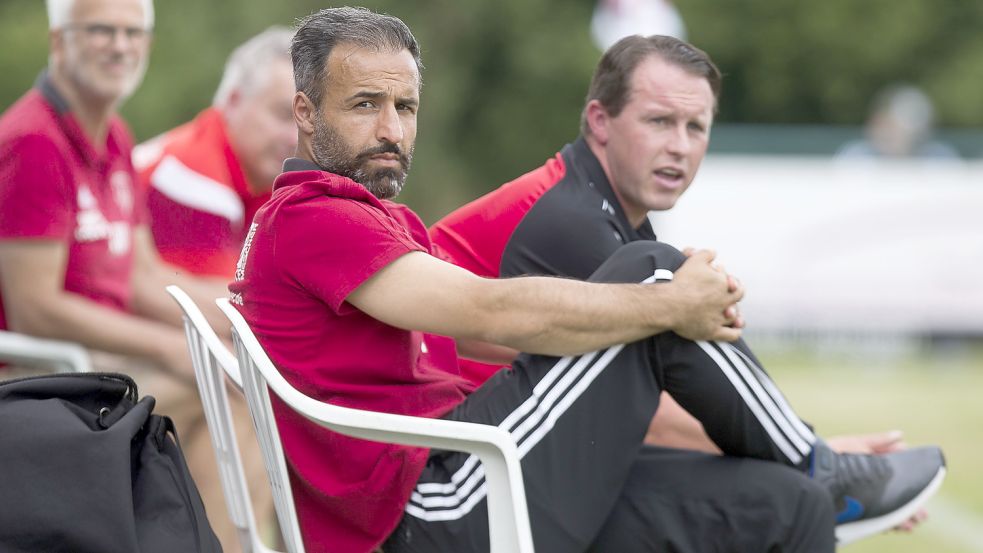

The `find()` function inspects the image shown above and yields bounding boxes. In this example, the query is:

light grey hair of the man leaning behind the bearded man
[212,26,294,108]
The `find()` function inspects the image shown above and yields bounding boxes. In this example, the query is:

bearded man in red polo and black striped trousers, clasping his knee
[230,8,944,553]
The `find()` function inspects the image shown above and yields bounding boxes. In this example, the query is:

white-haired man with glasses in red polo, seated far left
[0,0,266,551]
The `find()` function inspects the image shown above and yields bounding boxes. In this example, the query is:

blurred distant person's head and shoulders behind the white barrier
[836,84,959,160]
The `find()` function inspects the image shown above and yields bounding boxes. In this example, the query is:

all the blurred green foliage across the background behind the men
[0,0,983,221]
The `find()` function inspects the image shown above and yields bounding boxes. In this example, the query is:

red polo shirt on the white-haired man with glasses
[0,77,145,329]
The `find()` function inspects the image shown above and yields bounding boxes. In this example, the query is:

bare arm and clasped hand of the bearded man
[347,252,743,355]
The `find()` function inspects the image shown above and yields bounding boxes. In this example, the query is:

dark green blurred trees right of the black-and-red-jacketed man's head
[677,0,983,127]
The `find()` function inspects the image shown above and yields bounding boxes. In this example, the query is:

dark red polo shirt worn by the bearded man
[229,163,472,553]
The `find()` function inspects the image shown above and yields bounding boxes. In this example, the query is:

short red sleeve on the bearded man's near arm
[275,197,427,313]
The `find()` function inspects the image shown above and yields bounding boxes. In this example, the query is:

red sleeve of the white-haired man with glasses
[0,135,76,239]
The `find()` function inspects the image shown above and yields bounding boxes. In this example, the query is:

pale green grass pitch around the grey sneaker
[759,345,983,553]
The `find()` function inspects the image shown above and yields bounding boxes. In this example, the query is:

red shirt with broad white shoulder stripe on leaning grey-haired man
[133,108,270,277]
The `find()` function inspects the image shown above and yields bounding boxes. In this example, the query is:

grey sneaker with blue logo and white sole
[809,440,945,545]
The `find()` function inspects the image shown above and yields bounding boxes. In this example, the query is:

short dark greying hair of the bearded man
[290,7,423,107]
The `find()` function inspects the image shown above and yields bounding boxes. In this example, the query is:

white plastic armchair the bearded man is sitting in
[215,298,534,553]
